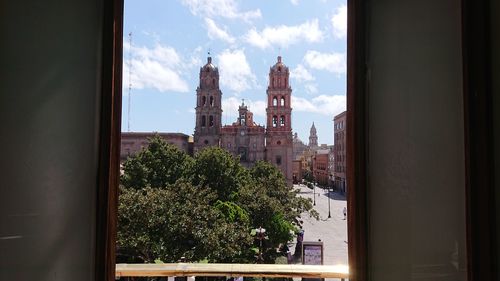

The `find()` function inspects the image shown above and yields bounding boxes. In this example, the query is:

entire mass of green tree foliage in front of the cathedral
[117,136,318,262]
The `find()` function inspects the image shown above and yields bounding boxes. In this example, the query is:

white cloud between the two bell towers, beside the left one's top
[217,49,256,93]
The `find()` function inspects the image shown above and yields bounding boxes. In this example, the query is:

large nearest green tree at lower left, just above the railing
[117,181,252,262]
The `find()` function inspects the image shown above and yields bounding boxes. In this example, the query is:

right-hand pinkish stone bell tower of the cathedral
[266,56,293,185]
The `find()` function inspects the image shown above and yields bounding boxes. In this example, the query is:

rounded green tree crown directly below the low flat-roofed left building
[121,135,193,189]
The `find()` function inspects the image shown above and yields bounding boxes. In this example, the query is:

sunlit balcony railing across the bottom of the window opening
[116,263,349,280]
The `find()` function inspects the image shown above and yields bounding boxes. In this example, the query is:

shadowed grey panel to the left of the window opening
[0,0,102,280]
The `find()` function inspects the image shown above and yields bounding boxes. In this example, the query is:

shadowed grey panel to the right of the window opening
[367,0,466,281]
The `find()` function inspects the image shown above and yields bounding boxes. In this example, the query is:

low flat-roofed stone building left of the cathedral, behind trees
[120,132,192,161]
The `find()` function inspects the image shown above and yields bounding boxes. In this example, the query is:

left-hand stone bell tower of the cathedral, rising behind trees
[194,57,222,153]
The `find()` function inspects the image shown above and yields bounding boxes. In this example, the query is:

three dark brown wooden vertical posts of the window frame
[95,0,496,281]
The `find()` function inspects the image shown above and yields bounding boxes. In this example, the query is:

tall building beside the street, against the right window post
[333,111,347,192]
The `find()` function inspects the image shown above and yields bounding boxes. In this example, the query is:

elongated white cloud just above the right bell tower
[245,19,323,49]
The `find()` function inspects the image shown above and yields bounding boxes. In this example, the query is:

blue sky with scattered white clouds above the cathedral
[122,0,347,144]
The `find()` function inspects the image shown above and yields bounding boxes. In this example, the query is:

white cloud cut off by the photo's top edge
[182,0,262,22]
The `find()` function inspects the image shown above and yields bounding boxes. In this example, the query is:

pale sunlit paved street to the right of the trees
[290,185,347,265]
